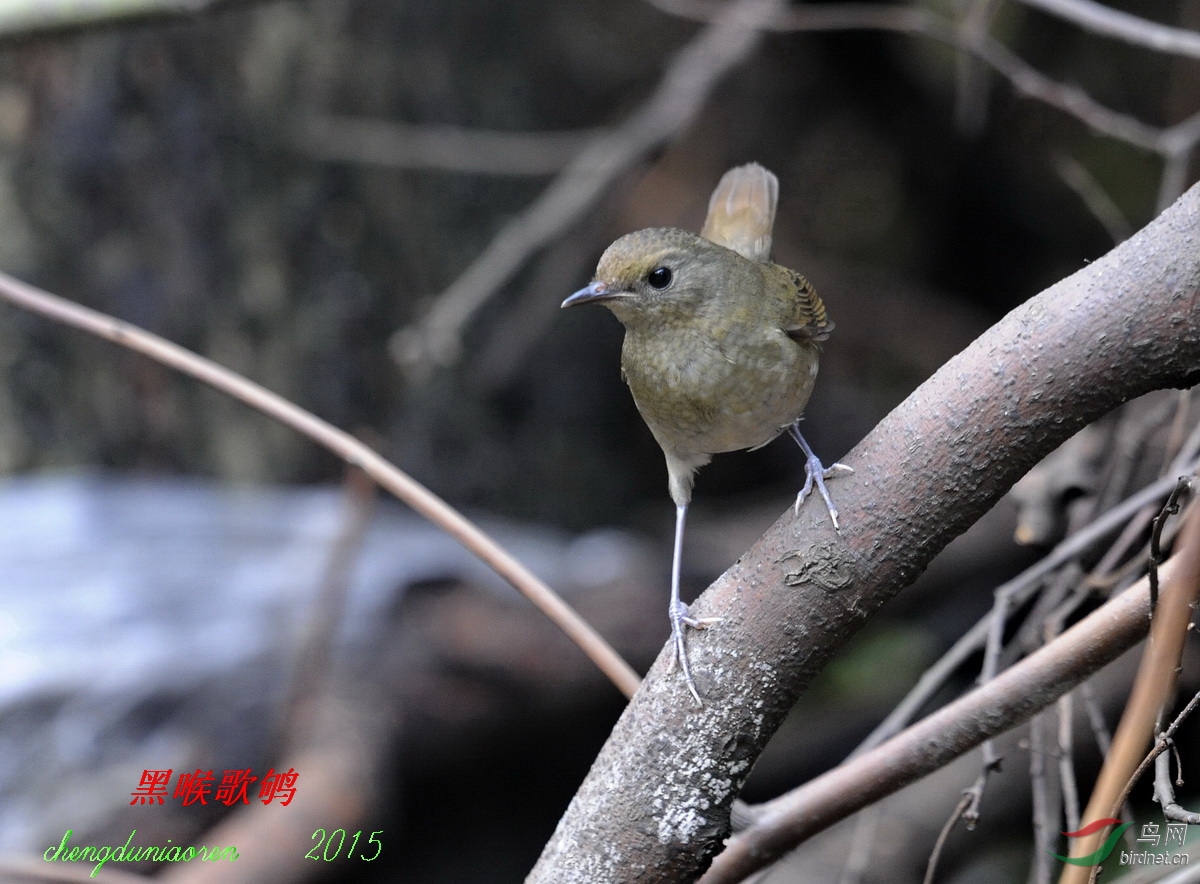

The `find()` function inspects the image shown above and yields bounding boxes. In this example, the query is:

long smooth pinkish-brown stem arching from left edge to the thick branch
[0,273,638,697]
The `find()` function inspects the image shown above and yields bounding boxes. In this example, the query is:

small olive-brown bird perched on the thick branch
[563,163,851,703]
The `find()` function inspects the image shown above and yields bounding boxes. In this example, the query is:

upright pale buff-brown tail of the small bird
[700,163,779,261]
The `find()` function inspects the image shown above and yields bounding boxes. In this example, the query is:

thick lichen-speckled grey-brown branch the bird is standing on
[528,186,1200,884]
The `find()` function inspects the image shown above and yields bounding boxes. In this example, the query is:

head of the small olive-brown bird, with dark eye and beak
[563,228,745,329]
